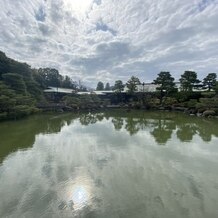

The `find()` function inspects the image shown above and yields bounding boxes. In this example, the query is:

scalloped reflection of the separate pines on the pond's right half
[76,111,218,145]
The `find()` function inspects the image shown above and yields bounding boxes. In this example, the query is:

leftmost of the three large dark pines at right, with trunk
[154,72,176,104]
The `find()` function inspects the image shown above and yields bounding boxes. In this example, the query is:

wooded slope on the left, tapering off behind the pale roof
[0,51,86,120]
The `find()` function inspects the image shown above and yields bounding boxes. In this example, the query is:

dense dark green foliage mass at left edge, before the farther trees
[0,52,43,119]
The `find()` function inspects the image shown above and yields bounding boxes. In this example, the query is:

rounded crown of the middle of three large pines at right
[179,71,200,92]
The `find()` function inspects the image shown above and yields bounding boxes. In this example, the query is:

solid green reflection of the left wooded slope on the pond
[0,114,77,163]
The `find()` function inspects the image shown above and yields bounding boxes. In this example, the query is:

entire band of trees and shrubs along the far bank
[0,51,218,120]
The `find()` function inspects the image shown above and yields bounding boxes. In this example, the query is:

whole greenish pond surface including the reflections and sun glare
[0,110,218,218]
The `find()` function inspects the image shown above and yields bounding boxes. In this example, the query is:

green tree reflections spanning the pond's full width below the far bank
[0,110,218,162]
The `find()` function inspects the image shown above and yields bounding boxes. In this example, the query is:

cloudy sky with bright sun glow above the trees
[0,0,218,87]
